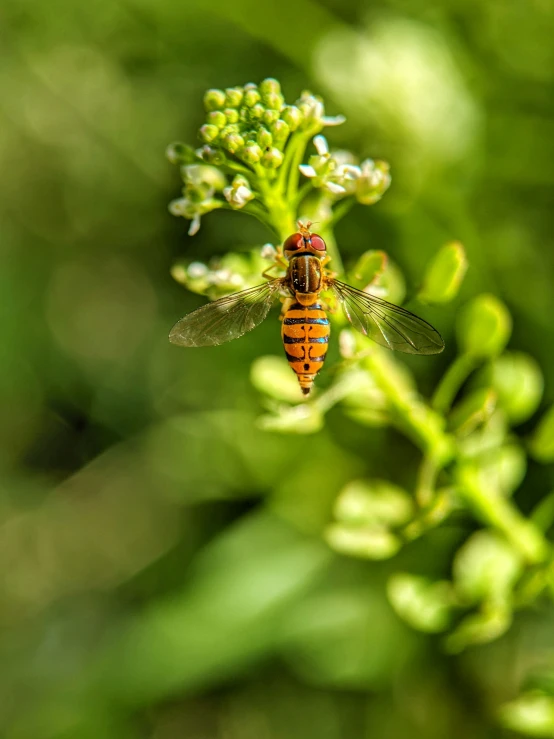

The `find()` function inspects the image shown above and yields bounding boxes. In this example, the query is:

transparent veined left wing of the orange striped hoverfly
[169,279,283,346]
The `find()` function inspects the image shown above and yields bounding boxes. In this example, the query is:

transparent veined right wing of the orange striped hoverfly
[331,280,444,354]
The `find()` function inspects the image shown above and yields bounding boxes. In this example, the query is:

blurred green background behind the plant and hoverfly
[0,0,554,739]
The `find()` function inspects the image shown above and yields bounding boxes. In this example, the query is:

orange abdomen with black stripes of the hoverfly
[281,298,331,395]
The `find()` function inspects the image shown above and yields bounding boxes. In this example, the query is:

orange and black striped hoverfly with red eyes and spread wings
[169,222,444,395]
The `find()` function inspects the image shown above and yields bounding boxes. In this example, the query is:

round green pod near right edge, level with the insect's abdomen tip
[479,352,544,423]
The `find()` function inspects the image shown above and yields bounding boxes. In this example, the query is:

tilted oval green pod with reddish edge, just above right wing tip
[418,241,468,303]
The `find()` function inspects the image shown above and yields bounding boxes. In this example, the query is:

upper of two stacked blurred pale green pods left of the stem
[334,480,414,526]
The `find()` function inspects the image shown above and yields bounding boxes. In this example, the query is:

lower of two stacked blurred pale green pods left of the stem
[325,523,402,559]
